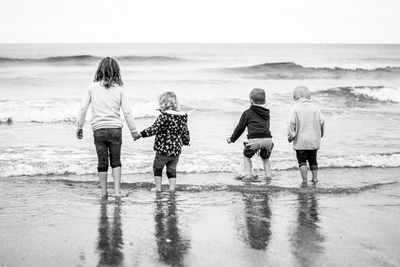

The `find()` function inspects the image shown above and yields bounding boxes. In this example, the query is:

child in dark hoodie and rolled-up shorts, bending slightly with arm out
[226,88,274,179]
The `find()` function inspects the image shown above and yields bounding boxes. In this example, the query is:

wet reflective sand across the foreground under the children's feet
[0,168,400,266]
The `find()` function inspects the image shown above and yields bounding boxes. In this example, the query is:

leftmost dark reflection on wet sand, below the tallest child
[97,201,124,266]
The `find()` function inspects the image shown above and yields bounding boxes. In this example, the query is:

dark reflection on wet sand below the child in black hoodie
[243,194,271,250]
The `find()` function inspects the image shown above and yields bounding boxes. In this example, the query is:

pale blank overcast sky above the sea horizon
[0,0,400,43]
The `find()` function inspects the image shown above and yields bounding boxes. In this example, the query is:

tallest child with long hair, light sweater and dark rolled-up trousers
[76,57,139,198]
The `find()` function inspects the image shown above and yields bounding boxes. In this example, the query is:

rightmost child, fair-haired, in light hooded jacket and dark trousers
[288,86,325,183]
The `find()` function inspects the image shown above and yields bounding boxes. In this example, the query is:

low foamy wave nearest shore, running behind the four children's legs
[0,146,400,177]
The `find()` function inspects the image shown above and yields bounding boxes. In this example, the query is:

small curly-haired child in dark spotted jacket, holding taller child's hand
[137,92,190,192]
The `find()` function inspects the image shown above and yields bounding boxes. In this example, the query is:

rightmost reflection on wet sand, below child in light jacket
[291,193,324,266]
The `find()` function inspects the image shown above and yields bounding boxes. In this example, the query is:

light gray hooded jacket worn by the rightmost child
[287,98,325,150]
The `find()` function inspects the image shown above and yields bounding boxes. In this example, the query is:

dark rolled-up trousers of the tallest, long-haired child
[93,128,122,172]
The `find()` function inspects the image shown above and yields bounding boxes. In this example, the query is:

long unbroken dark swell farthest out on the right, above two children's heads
[222,62,400,80]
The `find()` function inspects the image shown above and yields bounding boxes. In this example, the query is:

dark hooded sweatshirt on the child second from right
[231,105,272,142]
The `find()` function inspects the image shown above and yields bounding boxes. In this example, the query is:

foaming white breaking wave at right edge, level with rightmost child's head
[317,86,400,103]
